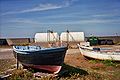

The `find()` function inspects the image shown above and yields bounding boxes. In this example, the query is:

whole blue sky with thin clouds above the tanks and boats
[0,0,120,38]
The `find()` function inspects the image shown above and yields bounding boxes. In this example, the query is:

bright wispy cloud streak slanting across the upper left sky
[2,0,76,15]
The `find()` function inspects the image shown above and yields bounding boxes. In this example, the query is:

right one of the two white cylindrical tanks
[60,32,85,42]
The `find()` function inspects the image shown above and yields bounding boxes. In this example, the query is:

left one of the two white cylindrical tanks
[35,32,59,42]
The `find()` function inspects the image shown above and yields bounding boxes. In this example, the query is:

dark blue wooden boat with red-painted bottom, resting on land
[13,46,68,73]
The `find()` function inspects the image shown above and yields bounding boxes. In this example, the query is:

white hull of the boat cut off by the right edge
[79,46,120,61]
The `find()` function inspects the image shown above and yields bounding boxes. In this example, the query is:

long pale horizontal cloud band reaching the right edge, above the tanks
[6,18,120,25]
